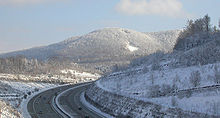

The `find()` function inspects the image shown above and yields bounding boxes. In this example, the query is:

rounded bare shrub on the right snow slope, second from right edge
[190,71,201,87]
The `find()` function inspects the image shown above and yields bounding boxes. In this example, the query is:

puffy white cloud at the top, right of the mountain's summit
[116,0,188,17]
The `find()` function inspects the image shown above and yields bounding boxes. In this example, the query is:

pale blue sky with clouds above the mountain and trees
[0,0,220,53]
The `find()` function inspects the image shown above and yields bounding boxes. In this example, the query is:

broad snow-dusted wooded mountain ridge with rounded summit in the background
[0,28,179,62]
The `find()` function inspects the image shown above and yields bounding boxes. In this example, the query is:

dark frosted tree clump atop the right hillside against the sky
[174,14,220,51]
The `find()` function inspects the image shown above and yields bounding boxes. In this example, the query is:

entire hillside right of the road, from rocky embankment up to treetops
[85,15,220,118]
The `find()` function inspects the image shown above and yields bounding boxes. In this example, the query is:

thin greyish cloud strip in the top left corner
[0,0,64,6]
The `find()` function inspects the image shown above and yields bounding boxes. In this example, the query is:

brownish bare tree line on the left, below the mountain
[0,55,78,74]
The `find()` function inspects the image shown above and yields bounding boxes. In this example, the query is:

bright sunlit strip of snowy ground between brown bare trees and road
[0,69,100,83]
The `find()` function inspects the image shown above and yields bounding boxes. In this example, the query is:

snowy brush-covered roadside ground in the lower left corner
[0,80,55,118]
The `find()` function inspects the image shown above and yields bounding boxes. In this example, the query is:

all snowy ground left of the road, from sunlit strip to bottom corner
[0,69,99,118]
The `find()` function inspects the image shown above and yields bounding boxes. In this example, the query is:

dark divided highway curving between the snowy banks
[27,83,102,118]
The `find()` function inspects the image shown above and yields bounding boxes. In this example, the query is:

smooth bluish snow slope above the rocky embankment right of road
[96,63,220,115]
